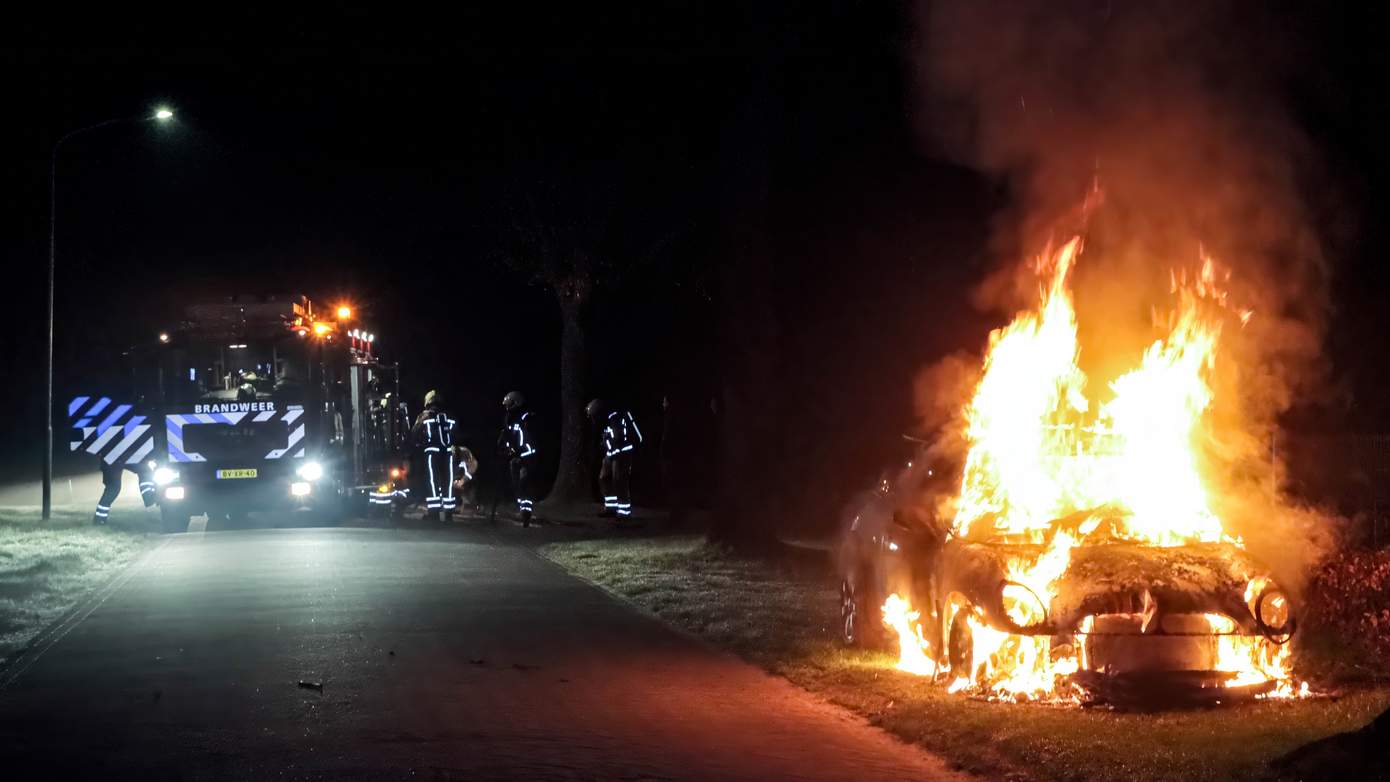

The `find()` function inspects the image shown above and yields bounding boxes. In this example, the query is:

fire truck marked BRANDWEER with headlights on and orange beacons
[132,296,410,532]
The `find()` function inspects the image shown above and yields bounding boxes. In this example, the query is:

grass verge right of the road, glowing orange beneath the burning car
[542,536,1390,782]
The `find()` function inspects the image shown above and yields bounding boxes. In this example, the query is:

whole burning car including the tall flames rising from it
[838,239,1295,706]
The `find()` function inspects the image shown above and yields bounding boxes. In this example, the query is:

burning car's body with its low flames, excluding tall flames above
[841,489,1295,706]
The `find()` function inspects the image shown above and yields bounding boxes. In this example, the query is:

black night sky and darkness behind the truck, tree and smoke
[0,1,1390,533]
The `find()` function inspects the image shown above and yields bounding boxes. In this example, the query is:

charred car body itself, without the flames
[838,452,1295,704]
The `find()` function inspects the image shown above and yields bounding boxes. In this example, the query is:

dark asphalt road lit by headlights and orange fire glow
[0,528,954,781]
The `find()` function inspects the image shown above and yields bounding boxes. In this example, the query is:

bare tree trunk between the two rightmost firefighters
[545,278,594,507]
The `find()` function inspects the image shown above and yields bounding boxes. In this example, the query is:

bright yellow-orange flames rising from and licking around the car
[884,236,1307,699]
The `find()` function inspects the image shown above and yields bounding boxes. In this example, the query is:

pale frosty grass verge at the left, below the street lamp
[0,508,158,661]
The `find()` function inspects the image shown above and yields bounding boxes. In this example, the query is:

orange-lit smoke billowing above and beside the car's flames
[913,0,1329,594]
